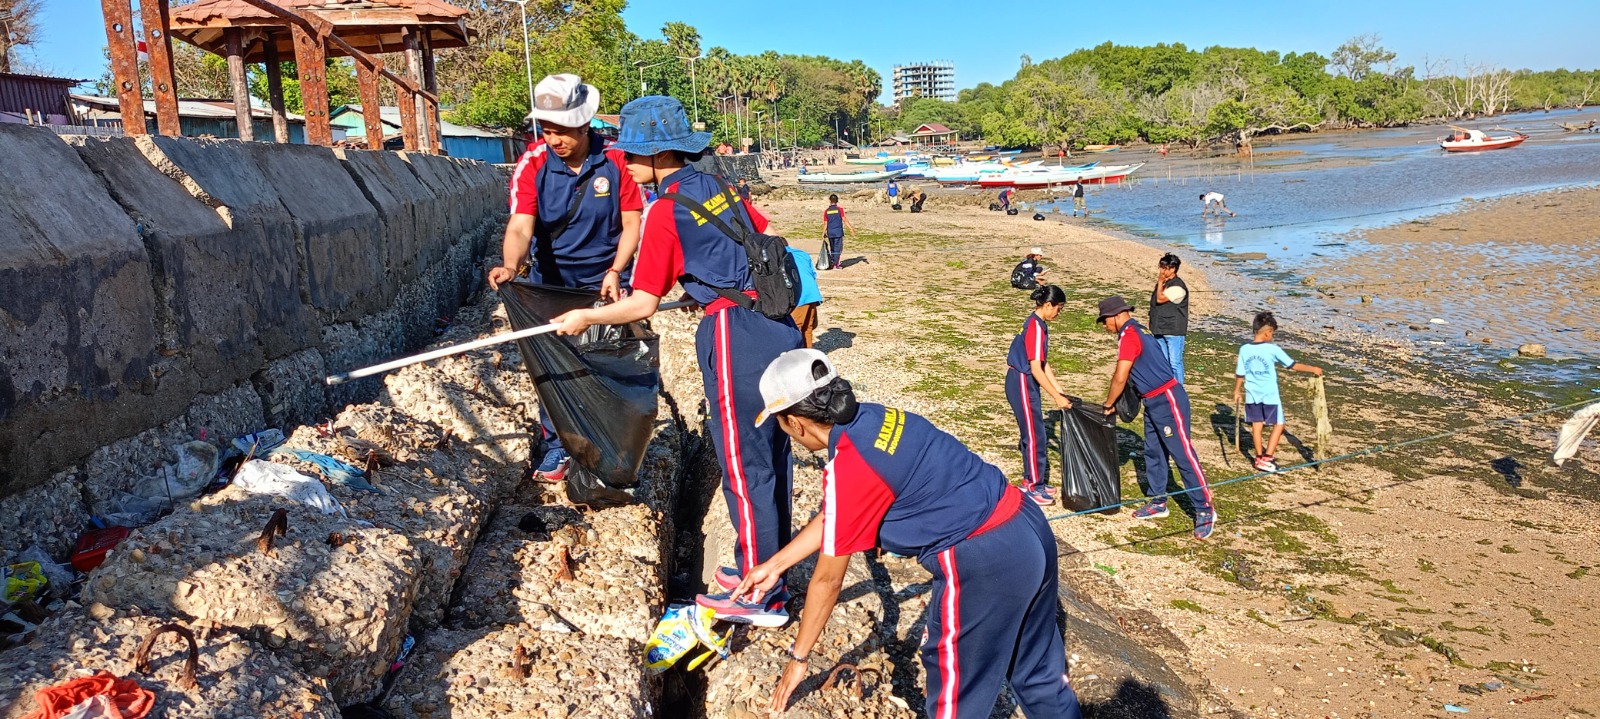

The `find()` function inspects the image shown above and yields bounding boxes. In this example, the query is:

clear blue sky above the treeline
[22,0,1600,88]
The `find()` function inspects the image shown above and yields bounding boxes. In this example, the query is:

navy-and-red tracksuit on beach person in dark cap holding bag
[1117,320,1211,509]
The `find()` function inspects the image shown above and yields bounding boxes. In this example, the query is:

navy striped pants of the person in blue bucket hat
[694,307,802,575]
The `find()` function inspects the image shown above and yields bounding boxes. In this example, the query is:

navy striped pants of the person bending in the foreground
[922,501,1082,719]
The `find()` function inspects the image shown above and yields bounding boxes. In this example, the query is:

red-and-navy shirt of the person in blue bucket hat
[634,167,766,312]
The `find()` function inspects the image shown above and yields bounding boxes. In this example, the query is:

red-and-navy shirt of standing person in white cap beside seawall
[510,136,645,288]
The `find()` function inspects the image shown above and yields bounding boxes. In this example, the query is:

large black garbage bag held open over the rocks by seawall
[501,283,661,508]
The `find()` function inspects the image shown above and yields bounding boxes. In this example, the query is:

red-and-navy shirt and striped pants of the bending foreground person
[822,404,1082,719]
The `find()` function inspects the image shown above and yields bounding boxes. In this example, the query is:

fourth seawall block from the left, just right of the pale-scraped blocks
[245,143,395,322]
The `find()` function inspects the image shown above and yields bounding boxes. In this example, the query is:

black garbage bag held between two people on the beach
[1051,397,1122,514]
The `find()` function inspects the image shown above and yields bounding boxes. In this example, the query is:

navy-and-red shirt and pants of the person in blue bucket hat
[634,168,802,575]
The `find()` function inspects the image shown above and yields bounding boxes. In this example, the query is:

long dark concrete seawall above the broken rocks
[0,125,506,554]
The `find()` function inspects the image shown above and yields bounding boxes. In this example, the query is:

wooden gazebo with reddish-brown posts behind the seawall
[101,0,470,152]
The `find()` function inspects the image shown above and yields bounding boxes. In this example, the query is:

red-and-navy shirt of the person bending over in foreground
[822,404,1006,559]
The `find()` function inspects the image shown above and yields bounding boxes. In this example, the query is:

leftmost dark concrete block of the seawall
[0,125,163,495]
